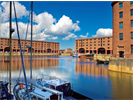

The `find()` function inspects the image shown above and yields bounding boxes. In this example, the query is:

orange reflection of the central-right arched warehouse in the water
[75,57,108,76]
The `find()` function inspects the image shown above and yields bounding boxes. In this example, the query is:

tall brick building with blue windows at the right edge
[111,1,133,58]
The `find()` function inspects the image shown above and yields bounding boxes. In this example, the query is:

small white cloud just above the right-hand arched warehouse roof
[93,28,113,37]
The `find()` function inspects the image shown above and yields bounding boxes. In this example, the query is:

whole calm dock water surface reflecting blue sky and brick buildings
[0,56,133,100]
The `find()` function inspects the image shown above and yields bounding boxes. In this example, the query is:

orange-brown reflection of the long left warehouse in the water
[0,56,59,71]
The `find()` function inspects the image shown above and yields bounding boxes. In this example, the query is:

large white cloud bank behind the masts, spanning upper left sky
[0,1,80,40]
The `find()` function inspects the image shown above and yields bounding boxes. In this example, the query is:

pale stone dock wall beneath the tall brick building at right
[108,57,133,73]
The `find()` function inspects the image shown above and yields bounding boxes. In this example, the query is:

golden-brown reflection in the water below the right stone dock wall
[108,71,133,100]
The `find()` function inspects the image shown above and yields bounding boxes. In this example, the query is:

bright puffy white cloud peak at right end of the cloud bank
[44,15,80,36]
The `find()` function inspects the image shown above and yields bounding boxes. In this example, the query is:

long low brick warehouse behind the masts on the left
[0,38,60,53]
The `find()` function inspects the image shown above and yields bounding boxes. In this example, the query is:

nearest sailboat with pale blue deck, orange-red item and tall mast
[13,1,63,100]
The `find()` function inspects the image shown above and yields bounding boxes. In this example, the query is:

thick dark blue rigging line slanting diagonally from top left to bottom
[13,1,30,100]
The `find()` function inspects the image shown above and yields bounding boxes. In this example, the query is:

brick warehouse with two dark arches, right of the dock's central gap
[75,36,112,54]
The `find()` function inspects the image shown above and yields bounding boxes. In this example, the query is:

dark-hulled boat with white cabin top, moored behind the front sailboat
[36,74,92,100]
